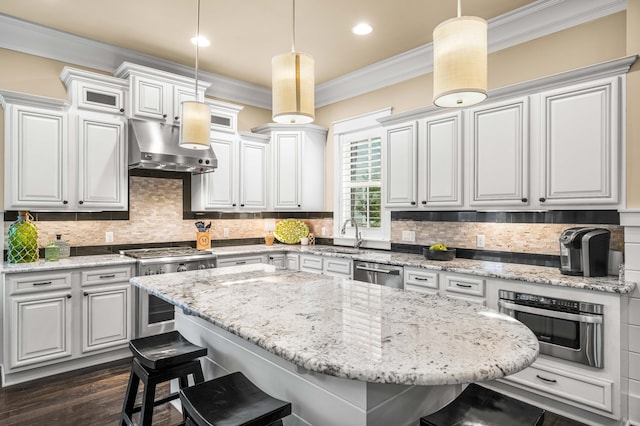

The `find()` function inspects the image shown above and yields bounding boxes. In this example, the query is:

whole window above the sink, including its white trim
[333,108,391,248]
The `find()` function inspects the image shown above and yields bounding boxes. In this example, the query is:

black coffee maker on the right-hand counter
[560,227,611,277]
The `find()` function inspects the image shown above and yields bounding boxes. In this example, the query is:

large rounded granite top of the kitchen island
[131,264,538,385]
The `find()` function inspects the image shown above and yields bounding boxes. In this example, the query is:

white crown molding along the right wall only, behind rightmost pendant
[316,0,627,107]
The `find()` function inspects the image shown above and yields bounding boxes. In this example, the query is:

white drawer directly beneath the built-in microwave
[504,363,613,413]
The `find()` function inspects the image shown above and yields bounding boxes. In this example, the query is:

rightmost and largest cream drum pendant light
[433,0,487,108]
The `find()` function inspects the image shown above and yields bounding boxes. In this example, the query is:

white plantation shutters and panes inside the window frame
[341,137,382,229]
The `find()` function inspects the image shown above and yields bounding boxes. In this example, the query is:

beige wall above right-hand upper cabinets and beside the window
[316,12,628,210]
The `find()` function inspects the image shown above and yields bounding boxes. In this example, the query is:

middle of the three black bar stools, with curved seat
[180,372,291,426]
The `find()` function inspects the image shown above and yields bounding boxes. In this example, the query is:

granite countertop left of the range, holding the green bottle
[0,254,136,274]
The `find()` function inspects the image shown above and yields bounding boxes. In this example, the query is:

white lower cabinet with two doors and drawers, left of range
[1,265,134,385]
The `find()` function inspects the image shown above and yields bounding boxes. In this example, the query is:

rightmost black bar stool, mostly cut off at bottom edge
[420,383,545,426]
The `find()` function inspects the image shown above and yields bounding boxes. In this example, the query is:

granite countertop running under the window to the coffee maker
[210,245,636,294]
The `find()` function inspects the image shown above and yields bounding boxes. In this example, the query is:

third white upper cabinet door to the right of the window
[467,97,530,207]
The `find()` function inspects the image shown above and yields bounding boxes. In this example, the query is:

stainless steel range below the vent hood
[120,247,216,337]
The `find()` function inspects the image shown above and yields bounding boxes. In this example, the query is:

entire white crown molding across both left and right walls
[0,0,627,109]
